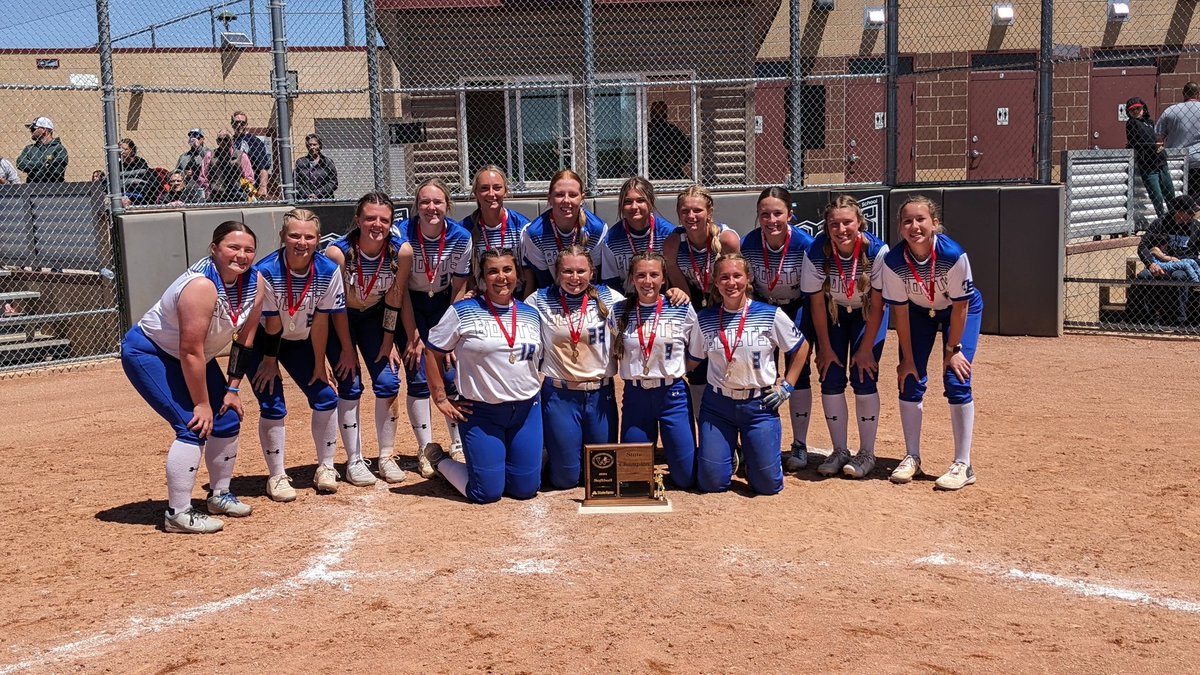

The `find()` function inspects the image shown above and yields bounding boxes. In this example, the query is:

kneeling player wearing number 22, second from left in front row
[532,245,623,490]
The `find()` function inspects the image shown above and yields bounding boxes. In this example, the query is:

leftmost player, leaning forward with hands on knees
[121,220,263,533]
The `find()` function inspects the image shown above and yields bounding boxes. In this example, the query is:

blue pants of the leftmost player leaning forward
[121,325,241,446]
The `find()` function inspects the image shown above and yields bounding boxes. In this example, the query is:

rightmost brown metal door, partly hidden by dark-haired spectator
[1087,66,1162,150]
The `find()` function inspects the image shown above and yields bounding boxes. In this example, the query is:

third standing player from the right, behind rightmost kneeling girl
[742,187,815,471]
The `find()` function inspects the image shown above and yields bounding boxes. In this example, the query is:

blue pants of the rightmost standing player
[900,292,983,405]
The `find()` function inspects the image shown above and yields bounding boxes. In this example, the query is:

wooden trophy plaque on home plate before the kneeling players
[580,443,671,513]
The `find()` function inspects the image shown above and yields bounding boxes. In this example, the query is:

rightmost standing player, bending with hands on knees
[883,195,983,490]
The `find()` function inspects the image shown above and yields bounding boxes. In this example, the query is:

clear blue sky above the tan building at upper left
[0,0,362,49]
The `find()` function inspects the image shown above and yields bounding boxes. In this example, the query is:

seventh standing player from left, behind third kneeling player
[595,175,676,288]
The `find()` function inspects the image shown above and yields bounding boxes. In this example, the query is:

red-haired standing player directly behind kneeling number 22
[521,169,606,293]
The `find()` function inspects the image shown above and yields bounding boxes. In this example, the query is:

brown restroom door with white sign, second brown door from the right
[967,71,1038,180]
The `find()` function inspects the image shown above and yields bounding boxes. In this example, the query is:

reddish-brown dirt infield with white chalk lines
[0,336,1200,674]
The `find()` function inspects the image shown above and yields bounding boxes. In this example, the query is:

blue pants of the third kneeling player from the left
[620,380,696,490]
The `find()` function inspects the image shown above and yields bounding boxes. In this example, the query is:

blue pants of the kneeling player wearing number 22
[541,380,617,490]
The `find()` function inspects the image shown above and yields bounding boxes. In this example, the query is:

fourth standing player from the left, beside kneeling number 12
[396,178,470,478]
